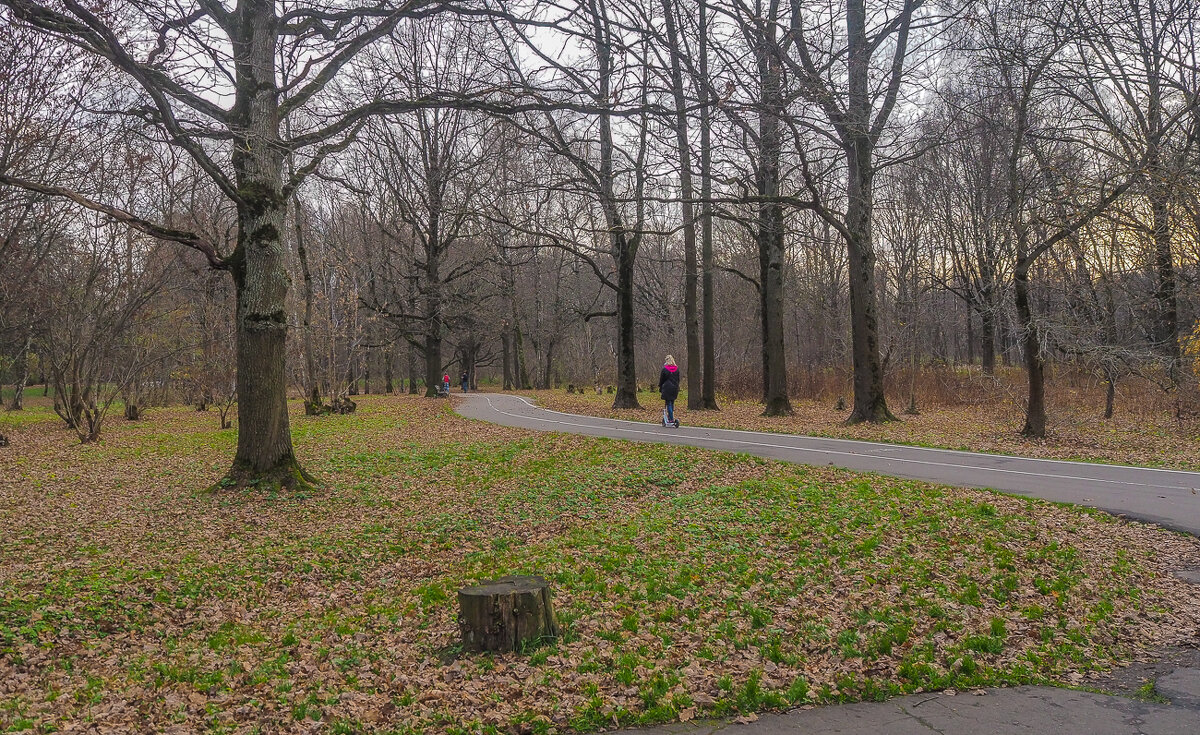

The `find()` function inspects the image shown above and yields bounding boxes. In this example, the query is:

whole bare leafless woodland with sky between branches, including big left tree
[0,0,1200,484]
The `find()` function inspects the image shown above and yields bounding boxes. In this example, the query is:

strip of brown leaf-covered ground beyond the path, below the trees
[522,390,1200,470]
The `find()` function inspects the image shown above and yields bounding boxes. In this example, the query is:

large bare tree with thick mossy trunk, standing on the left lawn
[0,0,501,486]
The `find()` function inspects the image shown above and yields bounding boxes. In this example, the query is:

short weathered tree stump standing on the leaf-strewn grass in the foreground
[458,576,558,651]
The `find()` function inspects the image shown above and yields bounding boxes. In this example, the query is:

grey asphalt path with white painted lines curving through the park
[455,393,1200,536]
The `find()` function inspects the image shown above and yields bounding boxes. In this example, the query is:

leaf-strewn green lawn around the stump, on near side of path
[0,396,1200,733]
